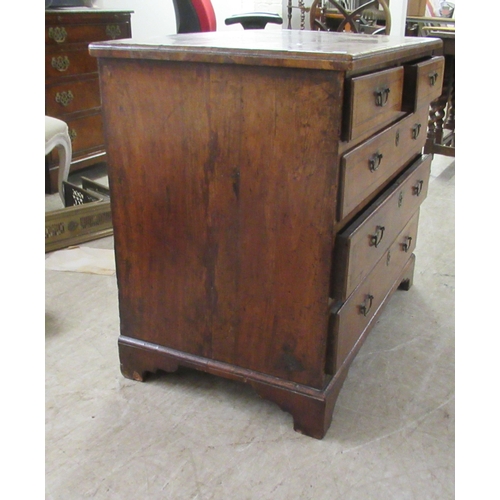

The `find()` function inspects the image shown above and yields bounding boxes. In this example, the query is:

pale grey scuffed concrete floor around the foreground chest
[45,156,455,500]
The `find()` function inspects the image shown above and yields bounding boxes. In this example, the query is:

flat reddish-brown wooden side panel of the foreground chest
[101,60,342,387]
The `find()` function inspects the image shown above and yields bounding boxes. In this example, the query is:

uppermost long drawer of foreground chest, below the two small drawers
[339,109,428,220]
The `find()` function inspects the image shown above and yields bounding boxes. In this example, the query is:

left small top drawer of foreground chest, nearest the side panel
[346,67,404,140]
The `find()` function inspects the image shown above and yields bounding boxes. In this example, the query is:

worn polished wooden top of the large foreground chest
[90,30,442,71]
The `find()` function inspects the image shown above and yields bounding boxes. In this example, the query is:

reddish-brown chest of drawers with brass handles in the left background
[45,7,131,192]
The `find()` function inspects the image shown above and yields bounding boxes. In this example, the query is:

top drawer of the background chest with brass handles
[45,20,130,46]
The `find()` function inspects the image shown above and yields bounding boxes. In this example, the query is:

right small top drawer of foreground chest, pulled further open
[403,56,444,110]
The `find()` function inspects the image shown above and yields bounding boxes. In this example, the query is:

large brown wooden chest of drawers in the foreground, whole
[90,30,443,438]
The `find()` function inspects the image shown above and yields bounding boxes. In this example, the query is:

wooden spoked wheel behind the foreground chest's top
[309,0,391,35]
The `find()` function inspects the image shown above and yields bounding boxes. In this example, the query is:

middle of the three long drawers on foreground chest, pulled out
[332,155,432,301]
